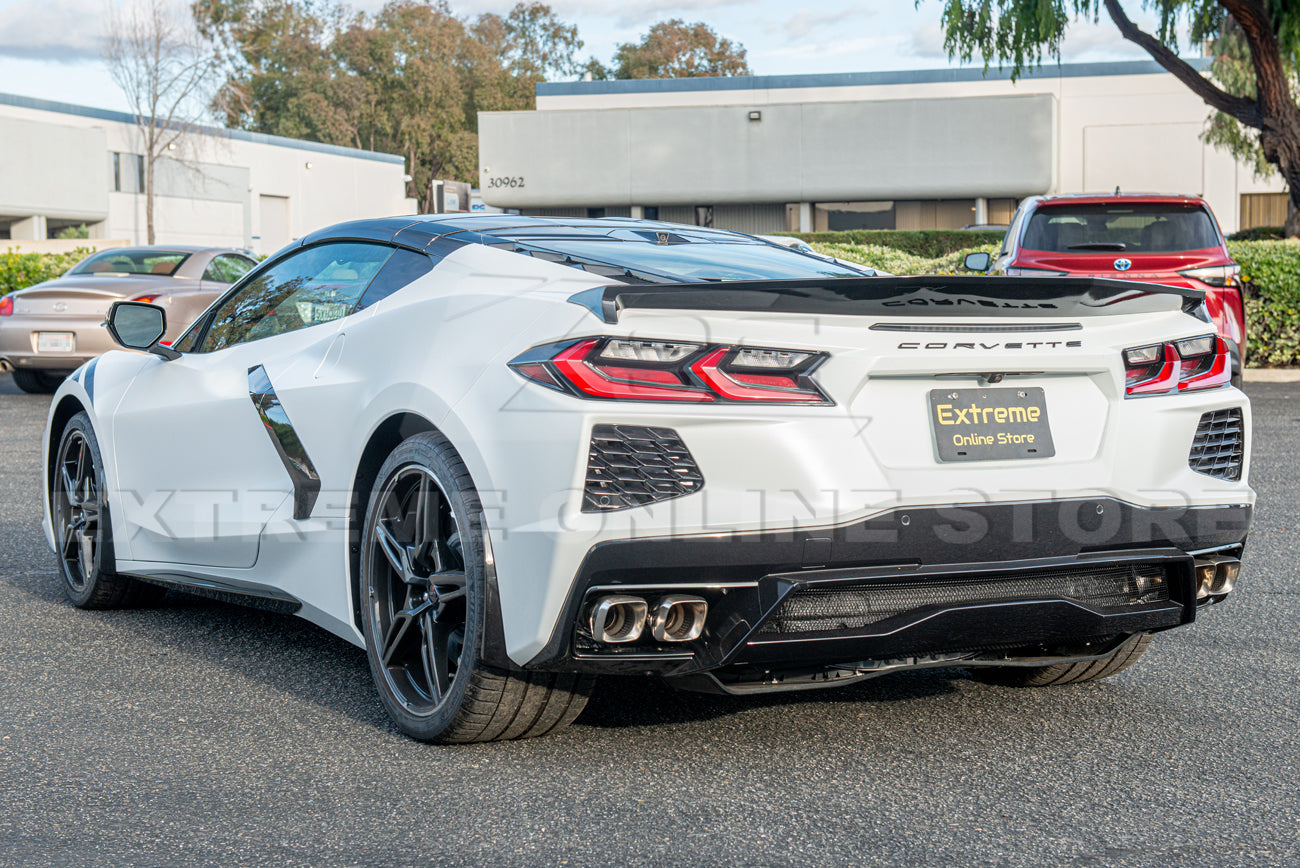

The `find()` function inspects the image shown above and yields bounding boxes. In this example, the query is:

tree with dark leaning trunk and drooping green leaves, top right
[943,0,1300,236]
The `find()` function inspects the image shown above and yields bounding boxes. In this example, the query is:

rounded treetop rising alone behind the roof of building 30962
[586,18,750,78]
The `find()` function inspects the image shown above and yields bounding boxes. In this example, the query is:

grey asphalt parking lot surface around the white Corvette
[0,376,1300,865]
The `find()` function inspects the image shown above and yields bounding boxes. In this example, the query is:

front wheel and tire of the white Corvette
[49,412,165,609]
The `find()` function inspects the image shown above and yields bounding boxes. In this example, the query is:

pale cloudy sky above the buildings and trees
[0,0,1185,110]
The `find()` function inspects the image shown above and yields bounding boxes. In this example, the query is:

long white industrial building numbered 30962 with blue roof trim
[478,60,1286,233]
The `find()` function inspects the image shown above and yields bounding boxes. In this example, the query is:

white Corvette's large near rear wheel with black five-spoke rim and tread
[360,431,594,743]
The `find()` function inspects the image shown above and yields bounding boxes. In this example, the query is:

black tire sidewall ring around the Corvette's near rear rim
[360,433,486,741]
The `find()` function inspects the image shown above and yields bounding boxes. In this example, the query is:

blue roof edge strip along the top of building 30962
[537,57,1213,96]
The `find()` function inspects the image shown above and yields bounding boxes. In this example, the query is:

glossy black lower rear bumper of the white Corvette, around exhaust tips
[528,498,1252,677]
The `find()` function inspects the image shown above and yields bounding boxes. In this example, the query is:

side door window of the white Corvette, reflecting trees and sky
[202,242,393,352]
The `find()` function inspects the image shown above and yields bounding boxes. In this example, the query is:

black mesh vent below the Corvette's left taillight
[582,425,705,512]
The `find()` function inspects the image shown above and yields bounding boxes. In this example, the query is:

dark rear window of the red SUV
[1021,204,1219,253]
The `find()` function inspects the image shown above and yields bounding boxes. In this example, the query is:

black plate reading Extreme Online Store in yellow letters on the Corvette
[930,387,1056,461]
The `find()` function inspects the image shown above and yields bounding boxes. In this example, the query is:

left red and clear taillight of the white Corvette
[510,338,832,404]
